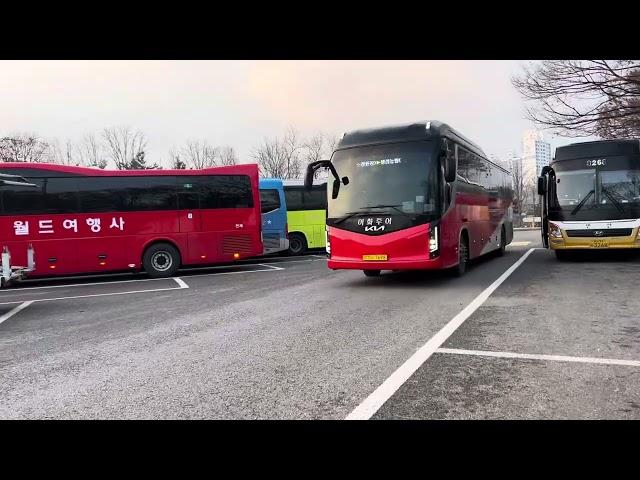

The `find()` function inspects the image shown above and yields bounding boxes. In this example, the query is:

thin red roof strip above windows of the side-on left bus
[0,162,258,177]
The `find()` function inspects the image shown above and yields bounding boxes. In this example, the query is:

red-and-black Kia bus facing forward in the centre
[305,121,513,276]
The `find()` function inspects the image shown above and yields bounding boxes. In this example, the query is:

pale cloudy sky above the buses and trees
[0,60,588,167]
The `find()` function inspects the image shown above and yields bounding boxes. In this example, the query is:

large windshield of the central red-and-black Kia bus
[328,141,438,218]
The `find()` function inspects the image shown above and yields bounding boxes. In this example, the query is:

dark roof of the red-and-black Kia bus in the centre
[336,120,487,159]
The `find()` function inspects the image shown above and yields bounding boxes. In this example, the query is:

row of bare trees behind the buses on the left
[0,127,338,179]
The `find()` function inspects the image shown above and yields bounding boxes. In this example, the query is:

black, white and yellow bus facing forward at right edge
[538,140,640,259]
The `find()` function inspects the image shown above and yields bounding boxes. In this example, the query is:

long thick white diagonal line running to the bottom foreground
[346,248,536,420]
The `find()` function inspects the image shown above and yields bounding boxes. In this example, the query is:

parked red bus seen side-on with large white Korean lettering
[0,163,263,277]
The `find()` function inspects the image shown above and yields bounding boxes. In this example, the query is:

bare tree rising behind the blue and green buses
[251,128,303,179]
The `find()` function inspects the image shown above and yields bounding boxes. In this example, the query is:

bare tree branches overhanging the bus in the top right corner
[512,60,640,138]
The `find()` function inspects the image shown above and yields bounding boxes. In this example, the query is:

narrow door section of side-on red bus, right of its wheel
[178,177,202,263]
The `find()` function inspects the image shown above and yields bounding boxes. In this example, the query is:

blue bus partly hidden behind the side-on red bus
[260,178,289,255]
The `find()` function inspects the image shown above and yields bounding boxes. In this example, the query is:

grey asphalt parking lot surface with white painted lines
[0,231,640,419]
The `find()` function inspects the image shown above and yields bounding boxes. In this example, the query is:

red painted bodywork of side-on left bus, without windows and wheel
[0,163,263,277]
